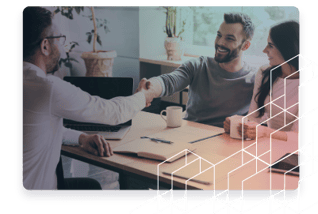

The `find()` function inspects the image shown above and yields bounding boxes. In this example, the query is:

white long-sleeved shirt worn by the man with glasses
[22,62,146,190]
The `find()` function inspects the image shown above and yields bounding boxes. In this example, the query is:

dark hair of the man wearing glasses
[23,6,53,60]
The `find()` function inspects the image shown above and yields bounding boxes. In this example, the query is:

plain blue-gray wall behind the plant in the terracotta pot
[43,6,140,90]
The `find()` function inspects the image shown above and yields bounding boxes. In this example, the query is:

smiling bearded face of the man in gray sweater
[214,22,245,63]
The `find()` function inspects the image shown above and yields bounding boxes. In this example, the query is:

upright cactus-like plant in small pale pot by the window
[163,6,185,61]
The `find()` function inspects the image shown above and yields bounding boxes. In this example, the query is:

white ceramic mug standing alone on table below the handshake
[160,106,182,128]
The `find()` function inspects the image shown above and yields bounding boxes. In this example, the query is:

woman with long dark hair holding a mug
[224,21,300,141]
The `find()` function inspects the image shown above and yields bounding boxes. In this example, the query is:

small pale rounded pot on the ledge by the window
[165,37,184,61]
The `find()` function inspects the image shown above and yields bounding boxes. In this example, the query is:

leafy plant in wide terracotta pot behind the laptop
[54,6,117,77]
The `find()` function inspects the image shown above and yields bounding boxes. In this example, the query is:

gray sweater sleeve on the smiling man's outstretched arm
[155,58,200,96]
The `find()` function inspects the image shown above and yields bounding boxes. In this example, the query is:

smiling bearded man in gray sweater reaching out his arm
[139,13,257,127]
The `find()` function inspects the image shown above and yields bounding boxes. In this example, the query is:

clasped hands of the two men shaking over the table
[136,78,162,107]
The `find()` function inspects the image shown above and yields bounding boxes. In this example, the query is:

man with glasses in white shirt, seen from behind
[22,7,153,191]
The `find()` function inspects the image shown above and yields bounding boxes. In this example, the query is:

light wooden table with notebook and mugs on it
[62,112,299,190]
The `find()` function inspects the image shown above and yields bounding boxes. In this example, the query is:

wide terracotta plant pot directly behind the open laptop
[81,51,117,77]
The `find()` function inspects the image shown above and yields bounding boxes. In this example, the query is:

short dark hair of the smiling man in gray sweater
[224,13,255,39]
